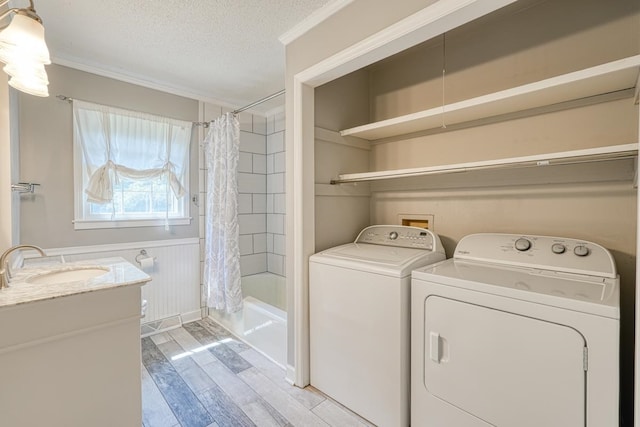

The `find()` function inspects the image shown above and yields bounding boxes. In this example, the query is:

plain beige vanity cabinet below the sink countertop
[0,260,150,427]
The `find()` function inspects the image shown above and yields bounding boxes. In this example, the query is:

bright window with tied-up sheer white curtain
[73,100,192,229]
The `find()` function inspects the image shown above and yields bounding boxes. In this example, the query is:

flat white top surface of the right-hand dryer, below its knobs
[412,259,620,319]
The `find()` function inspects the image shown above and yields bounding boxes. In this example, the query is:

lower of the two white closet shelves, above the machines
[331,143,638,184]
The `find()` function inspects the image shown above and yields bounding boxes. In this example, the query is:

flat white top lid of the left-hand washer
[309,243,445,277]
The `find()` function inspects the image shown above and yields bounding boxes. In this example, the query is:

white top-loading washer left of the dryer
[309,225,445,427]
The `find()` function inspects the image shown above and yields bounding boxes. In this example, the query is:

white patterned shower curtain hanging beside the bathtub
[203,113,242,313]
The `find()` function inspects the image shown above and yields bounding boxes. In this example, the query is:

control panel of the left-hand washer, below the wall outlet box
[355,225,439,250]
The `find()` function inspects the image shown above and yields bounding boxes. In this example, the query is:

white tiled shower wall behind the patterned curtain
[199,104,285,307]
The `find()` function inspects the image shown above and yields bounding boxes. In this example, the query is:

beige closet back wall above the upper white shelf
[370,0,640,121]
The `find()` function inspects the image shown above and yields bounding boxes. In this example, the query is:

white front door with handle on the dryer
[424,296,586,427]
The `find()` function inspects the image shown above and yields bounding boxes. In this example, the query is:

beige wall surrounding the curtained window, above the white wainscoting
[20,65,198,248]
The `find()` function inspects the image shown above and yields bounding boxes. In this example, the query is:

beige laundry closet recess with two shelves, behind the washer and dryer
[298,0,640,418]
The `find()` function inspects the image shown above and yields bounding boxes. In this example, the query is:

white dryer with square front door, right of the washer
[411,234,620,427]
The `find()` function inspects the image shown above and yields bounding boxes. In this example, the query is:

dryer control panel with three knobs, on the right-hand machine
[454,233,617,278]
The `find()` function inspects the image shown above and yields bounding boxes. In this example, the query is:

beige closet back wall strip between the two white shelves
[371,98,638,170]
